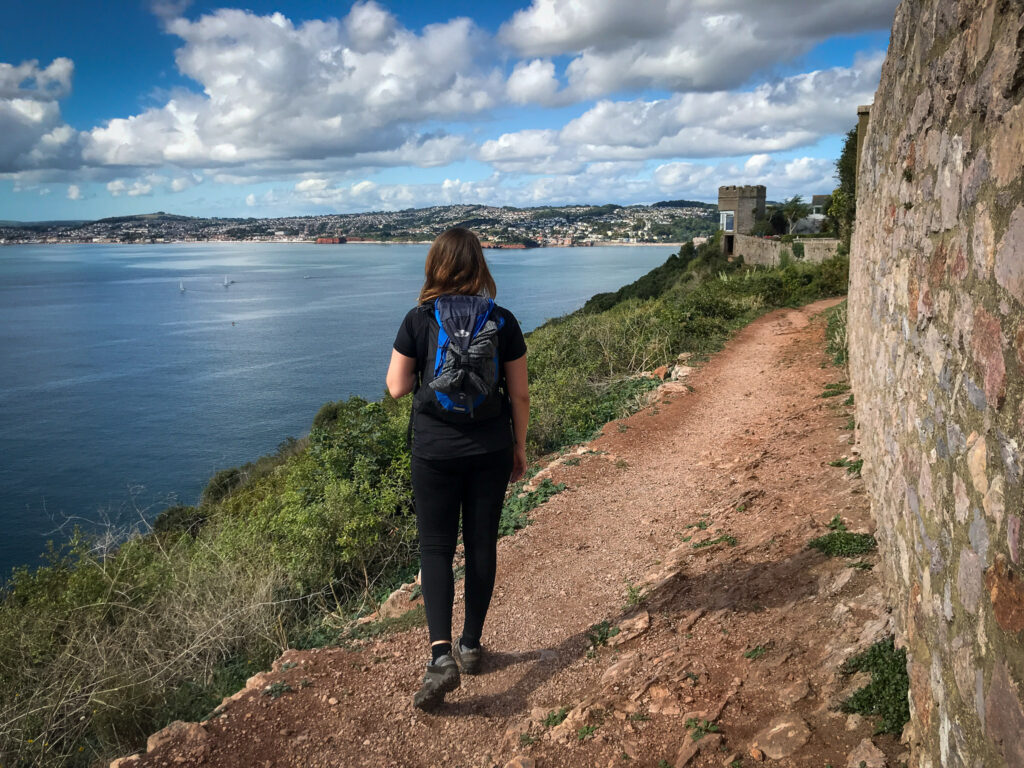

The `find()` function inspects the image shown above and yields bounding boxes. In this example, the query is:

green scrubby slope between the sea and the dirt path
[0,242,847,766]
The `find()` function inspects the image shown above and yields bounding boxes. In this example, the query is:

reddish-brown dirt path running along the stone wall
[126,302,902,768]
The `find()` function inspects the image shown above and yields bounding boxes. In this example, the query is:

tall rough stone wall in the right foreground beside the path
[849,0,1024,768]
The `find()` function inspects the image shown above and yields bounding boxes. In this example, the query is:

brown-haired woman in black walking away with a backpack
[387,227,529,710]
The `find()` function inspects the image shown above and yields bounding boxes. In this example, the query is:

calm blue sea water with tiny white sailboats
[0,244,674,579]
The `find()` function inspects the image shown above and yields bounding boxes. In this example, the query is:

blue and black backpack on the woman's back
[413,295,505,423]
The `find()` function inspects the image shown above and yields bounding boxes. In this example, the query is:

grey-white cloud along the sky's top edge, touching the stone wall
[499,0,897,103]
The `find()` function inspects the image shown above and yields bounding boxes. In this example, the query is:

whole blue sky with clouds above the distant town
[0,0,897,221]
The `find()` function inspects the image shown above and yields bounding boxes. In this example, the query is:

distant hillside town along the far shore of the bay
[0,200,719,248]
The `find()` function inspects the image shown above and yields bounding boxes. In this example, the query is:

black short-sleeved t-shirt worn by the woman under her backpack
[394,303,526,459]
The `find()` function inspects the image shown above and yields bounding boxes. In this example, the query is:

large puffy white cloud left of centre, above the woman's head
[84,3,495,167]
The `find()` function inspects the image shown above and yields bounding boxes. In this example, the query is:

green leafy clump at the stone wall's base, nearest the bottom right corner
[840,637,910,735]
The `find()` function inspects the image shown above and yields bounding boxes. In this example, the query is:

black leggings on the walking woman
[412,446,513,643]
